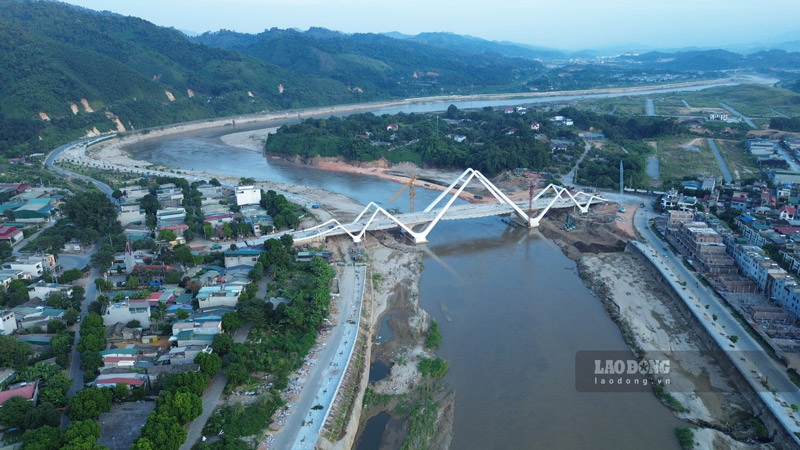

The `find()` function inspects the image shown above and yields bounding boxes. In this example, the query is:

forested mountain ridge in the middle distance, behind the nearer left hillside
[192,28,544,98]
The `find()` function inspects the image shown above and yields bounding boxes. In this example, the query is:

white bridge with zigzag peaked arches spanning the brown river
[292,169,606,244]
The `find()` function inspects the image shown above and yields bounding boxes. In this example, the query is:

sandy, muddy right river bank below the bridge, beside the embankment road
[542,205,772,449]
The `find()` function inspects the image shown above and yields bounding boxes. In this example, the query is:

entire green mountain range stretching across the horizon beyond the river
[0,0,800,156]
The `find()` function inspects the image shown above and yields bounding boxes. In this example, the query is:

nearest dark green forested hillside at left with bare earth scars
[0,0,360,156]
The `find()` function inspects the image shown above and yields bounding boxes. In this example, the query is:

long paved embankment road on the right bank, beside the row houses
[634,209,800,446]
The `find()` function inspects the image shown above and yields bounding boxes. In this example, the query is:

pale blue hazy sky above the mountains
[61,0,800,49]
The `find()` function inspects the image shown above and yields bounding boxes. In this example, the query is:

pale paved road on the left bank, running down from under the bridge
[270,266,366,450]
